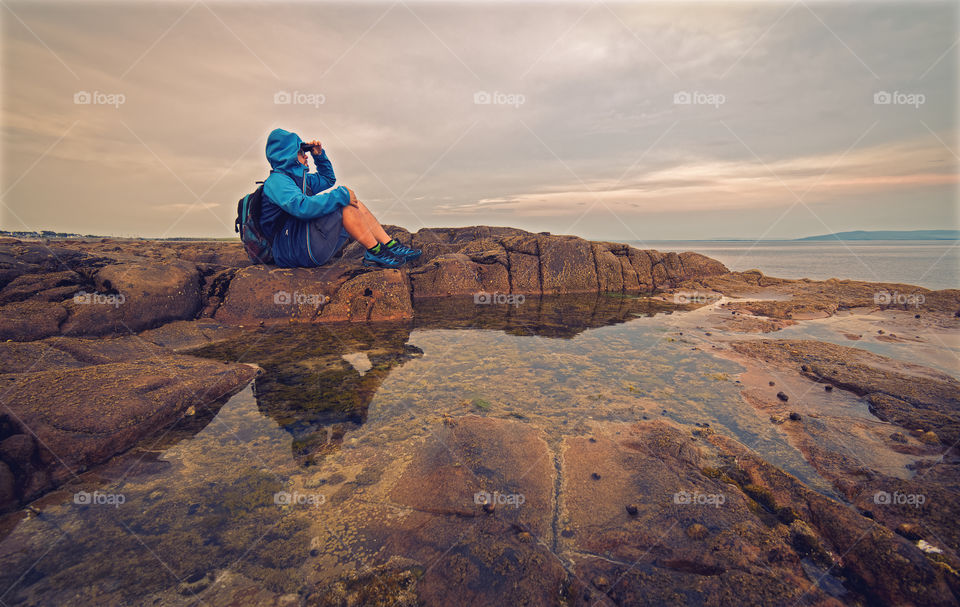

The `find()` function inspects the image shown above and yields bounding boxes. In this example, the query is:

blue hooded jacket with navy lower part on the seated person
[260,129,350,268]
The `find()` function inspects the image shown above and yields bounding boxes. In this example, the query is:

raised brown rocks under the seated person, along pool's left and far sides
[0,226,726,510]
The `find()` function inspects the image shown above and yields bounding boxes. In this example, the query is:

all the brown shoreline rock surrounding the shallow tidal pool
[0,226,960,605]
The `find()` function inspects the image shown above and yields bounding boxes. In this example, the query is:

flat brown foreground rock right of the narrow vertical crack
[560,422,827,605]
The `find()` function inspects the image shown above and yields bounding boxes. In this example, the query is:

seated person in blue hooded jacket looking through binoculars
[260,129,421,268]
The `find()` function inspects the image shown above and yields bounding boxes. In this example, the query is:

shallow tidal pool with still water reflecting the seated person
[0,297,833,605]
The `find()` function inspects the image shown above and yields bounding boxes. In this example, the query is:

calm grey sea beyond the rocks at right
[625,240,960,290]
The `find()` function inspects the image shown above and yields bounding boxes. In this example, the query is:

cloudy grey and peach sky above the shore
[0,0,960,240]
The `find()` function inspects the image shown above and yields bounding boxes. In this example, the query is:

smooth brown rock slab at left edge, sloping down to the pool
[0,354,256,507]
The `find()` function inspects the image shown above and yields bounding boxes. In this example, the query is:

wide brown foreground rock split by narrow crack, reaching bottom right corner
[305,415,953,606]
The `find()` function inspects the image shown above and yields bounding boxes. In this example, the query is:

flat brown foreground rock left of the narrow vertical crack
[300,416,567,605]
